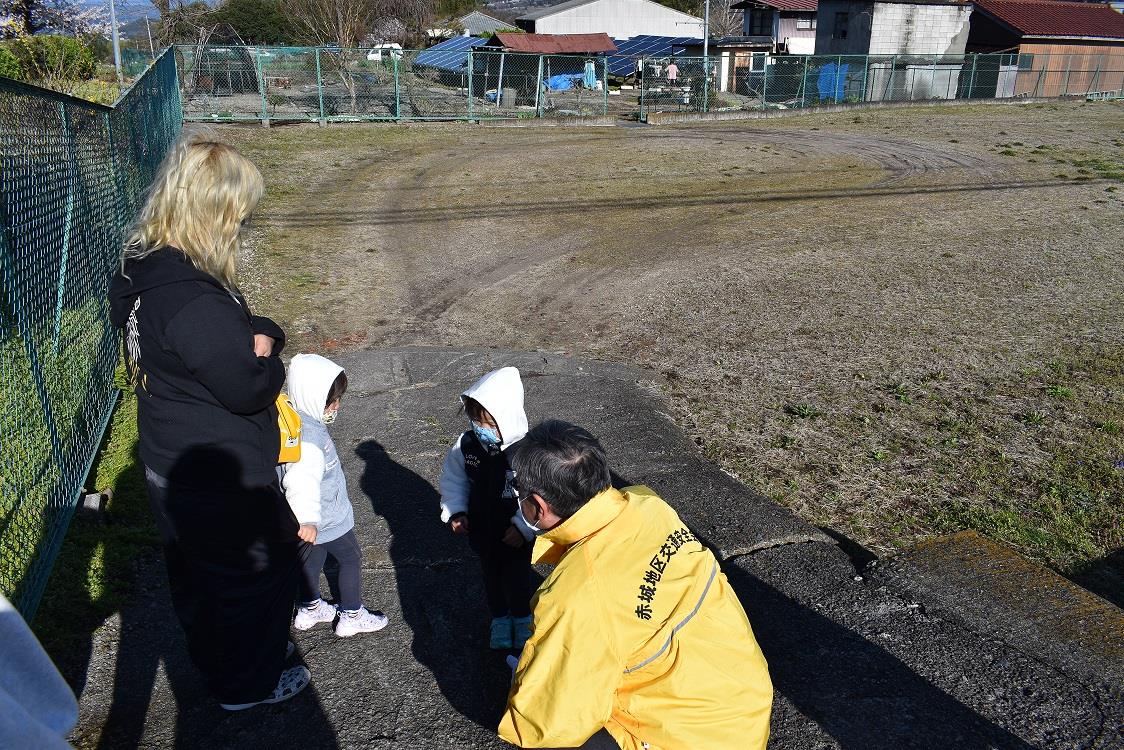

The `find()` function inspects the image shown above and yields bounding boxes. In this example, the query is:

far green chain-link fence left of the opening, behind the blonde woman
[175,46,609,121]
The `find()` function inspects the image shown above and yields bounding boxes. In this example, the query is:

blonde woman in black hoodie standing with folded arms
[110,141,309,711]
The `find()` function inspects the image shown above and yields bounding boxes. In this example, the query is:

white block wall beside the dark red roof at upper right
[870,2,972,55]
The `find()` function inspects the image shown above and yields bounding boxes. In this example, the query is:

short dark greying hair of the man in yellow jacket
[511,419,610,518]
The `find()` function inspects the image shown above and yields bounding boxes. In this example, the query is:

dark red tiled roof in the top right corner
[976,0,1124,39]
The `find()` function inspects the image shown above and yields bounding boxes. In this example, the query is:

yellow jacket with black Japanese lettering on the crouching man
[499,487,772,750]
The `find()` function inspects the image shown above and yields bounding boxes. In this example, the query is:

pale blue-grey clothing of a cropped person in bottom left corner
[0,594,78,750]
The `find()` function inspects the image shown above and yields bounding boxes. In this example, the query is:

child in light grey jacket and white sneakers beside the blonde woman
[281,354,387,638]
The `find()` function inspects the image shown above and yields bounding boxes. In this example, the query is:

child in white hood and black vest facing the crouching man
[438,368,534,650]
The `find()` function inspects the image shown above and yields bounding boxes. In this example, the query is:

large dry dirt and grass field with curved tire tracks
[218,103,1124,589]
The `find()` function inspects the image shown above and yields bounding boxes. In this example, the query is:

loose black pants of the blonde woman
[145,469,300,703]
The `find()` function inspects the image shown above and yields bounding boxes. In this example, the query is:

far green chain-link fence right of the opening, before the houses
[640,53,1124,118]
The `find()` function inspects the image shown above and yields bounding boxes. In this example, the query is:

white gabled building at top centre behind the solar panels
[516,0,703,39]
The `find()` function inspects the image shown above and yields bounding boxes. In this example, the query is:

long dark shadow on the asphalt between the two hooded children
[355,440,523,732]
